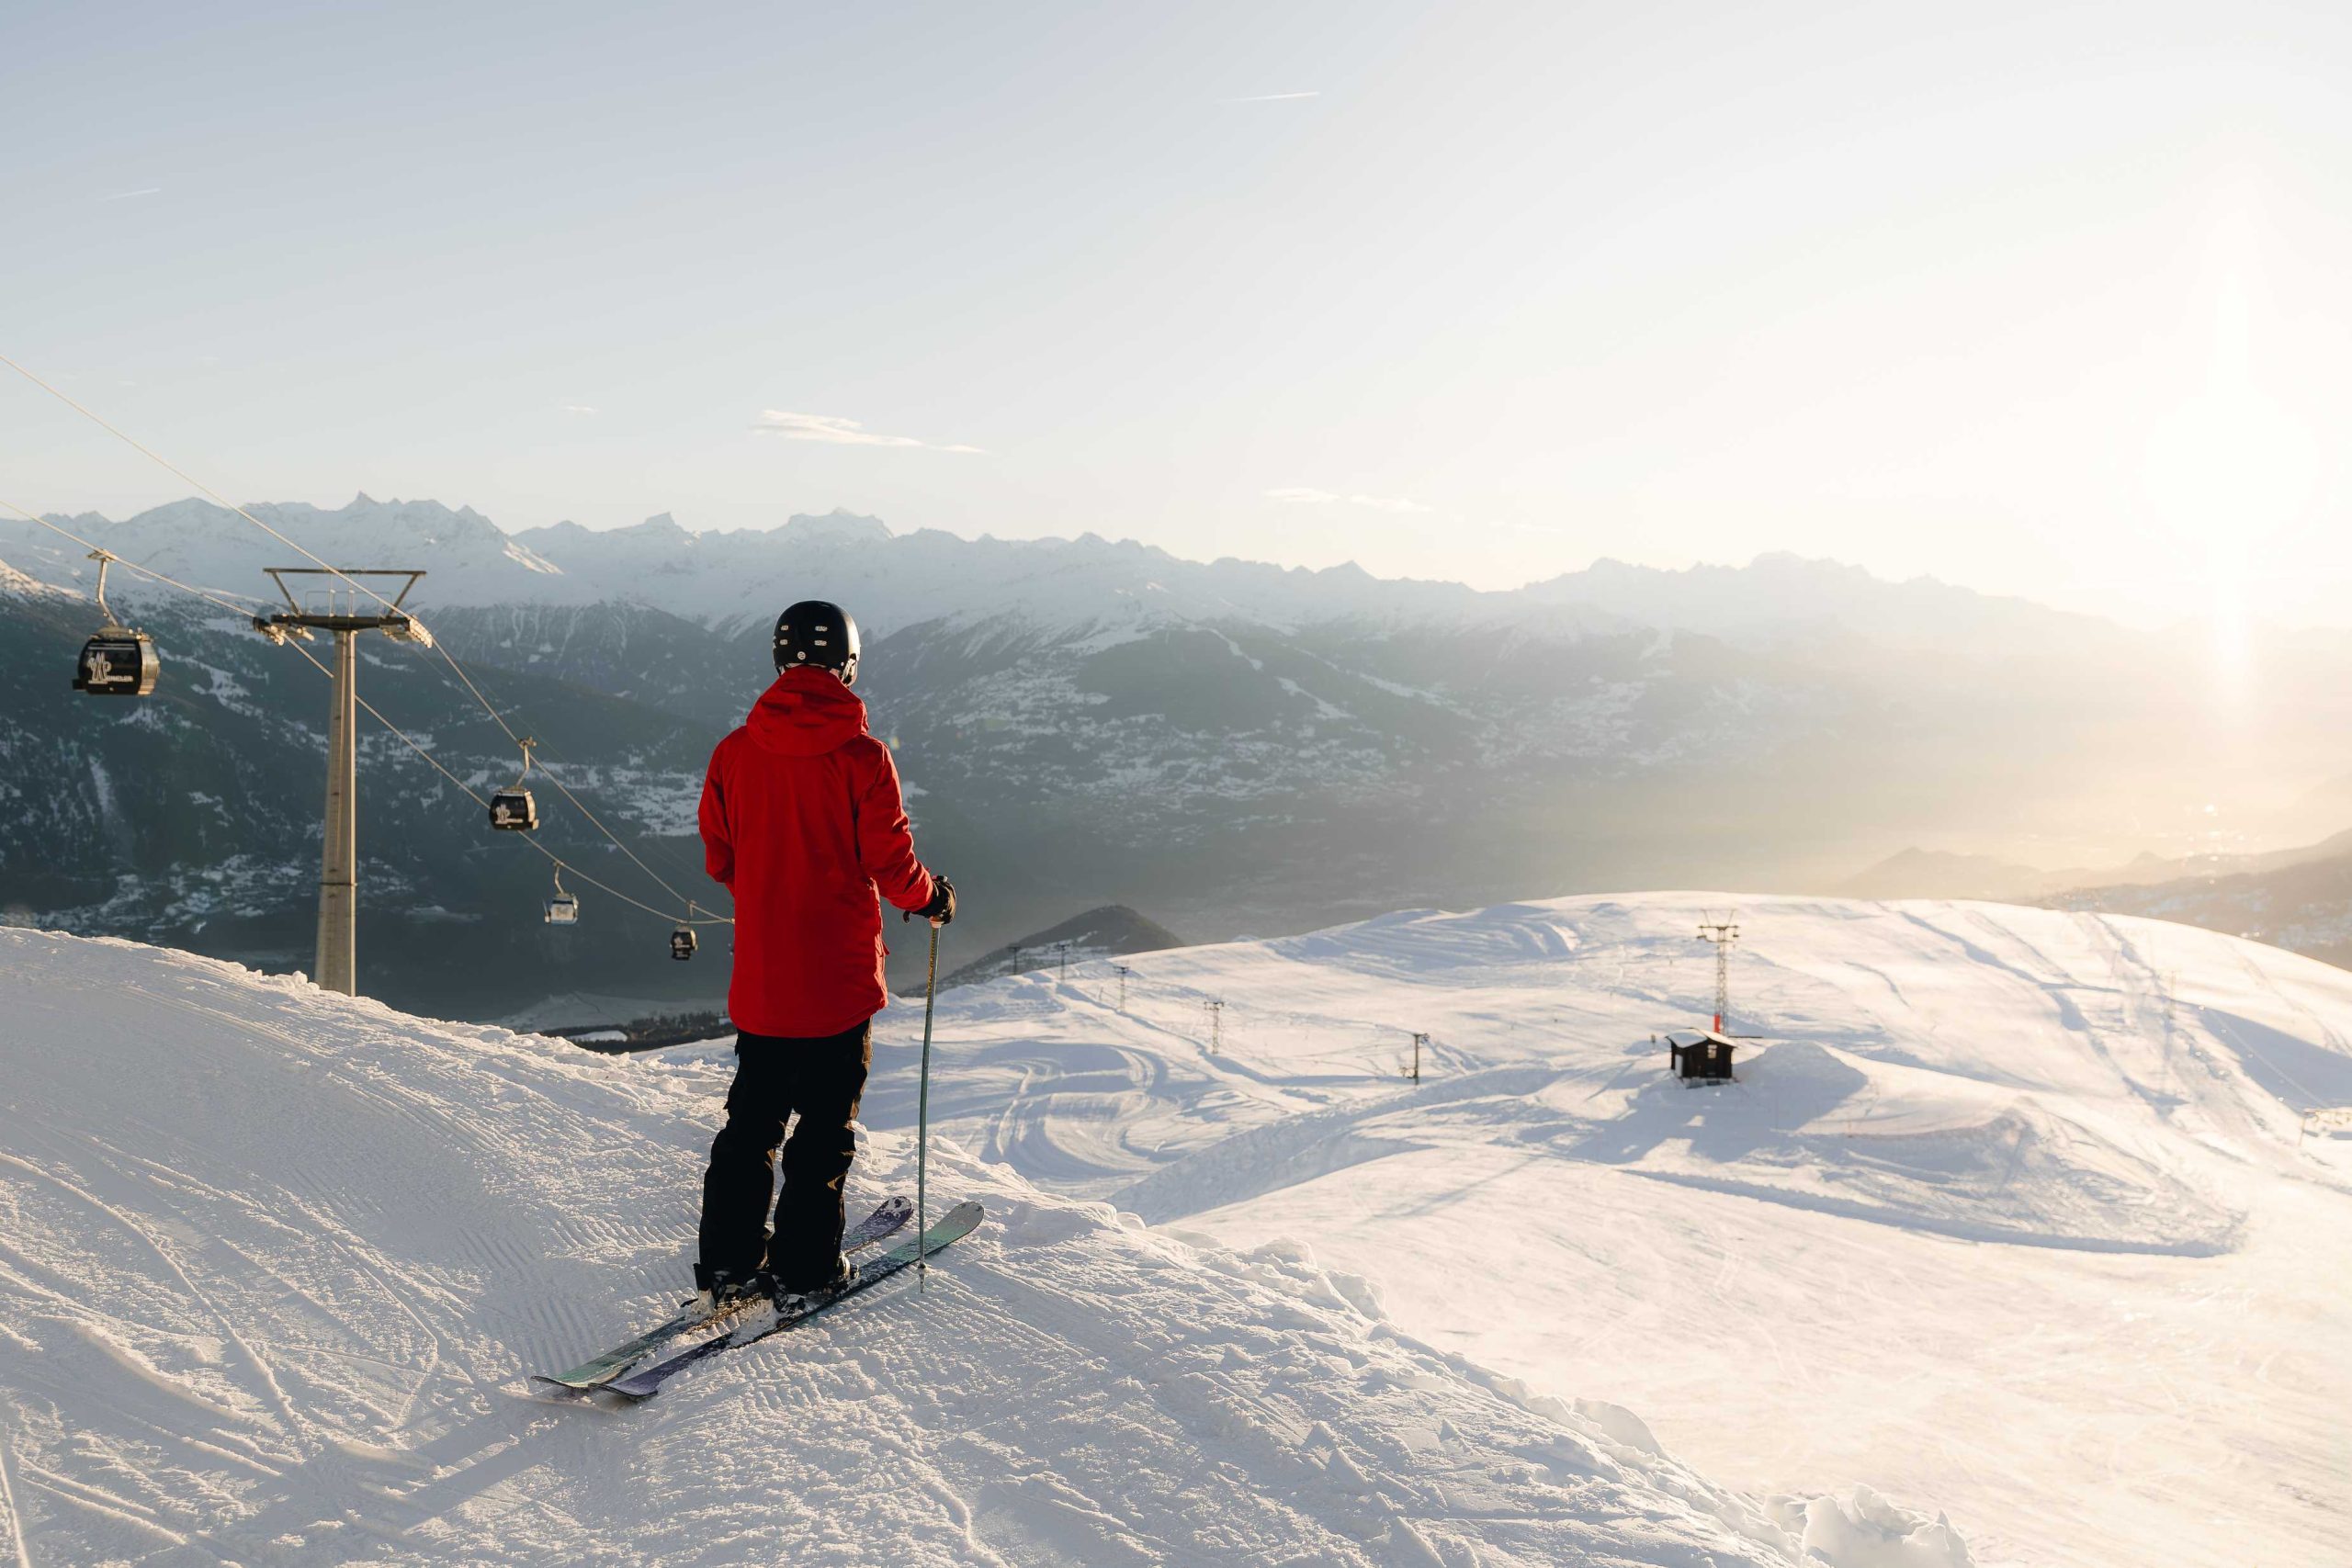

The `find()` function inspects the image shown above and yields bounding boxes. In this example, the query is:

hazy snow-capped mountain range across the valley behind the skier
[0,496,2352,1022]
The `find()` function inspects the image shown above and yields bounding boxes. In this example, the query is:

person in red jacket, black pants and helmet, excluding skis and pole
[694,600,955,1307]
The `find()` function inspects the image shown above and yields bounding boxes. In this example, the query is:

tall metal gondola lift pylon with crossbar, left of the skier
[254,567,433,997]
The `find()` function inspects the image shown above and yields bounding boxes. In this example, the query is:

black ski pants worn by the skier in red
[701,1018,873,1291]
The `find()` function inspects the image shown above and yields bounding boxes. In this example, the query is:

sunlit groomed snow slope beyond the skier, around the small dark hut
[832,896,2352,1568]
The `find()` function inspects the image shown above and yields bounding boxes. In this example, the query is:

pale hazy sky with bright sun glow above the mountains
[0,0,2352,626]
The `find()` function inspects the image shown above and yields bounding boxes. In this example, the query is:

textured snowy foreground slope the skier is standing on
[0,931,1966,1568]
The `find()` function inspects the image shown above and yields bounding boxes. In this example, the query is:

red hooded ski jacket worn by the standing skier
[701,668,932,1037]
